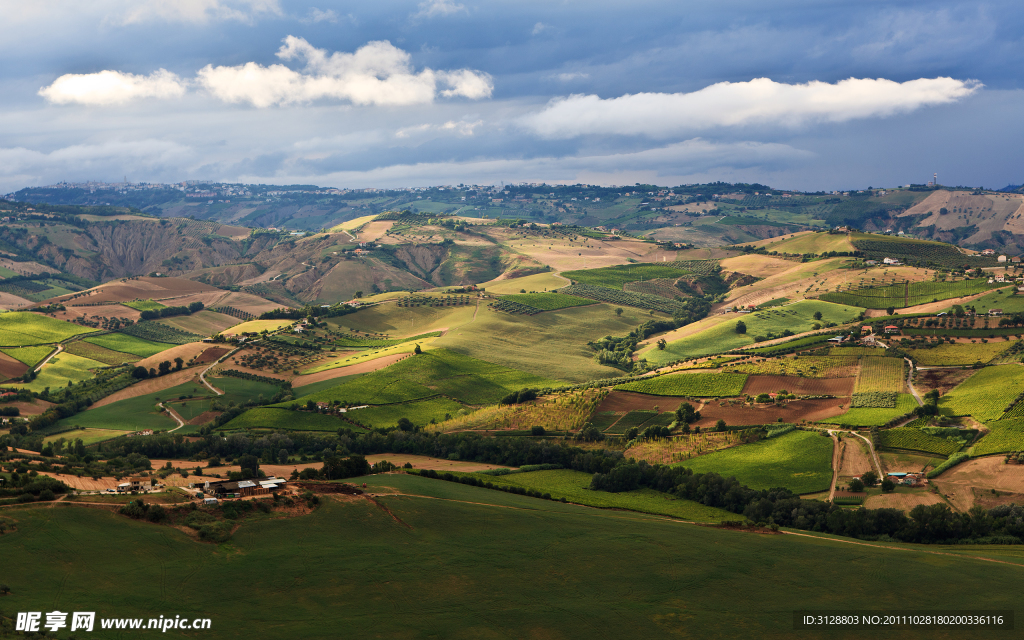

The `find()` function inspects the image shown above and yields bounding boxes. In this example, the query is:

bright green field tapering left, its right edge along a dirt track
[676,431,833,494]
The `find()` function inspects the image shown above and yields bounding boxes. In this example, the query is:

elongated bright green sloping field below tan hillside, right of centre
[643,300,861,364]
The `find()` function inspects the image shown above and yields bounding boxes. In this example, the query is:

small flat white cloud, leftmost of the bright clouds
[39,69,185,105]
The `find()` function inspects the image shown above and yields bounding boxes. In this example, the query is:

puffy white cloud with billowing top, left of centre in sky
[198,36,494,108]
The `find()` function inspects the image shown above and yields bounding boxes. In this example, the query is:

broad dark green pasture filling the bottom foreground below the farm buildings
[0,475,1024,640]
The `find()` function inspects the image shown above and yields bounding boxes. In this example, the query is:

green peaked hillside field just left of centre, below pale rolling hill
[284,349,558,404]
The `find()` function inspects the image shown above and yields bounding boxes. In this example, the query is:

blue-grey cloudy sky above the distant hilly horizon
[0,0,1024,193]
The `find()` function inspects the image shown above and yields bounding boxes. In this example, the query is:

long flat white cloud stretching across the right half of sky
[521,78,982,138]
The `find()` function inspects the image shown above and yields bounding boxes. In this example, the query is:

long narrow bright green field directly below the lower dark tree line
[456,469,736,522]
